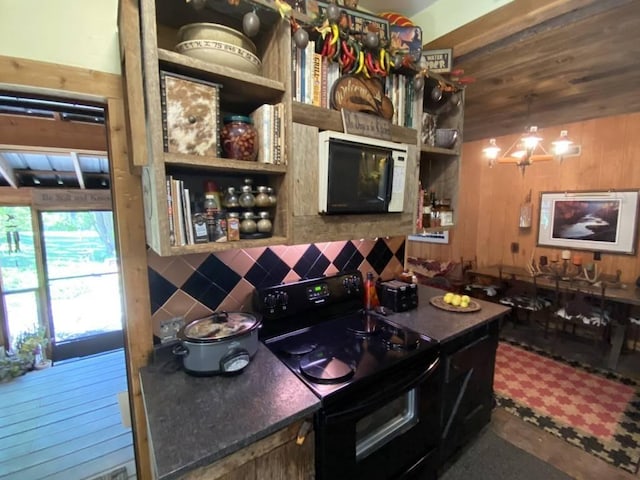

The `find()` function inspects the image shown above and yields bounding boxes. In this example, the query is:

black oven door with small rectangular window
[316,359,441,480]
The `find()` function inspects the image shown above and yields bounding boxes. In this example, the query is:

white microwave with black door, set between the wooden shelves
[318,130,409,215]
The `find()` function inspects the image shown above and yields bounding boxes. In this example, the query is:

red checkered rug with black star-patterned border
[494,342,640,473]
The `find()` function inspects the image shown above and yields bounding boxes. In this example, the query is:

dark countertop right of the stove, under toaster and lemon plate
[389,285,510,343]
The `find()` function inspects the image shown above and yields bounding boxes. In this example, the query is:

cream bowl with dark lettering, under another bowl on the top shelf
[176,40,262,75]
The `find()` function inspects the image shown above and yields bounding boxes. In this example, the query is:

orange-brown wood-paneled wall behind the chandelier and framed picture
[452,113,640,282]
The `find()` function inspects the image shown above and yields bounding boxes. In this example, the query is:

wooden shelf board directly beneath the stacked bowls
[158,48,285,103]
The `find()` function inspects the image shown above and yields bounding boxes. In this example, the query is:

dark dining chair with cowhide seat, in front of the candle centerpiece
[554,279,611,347]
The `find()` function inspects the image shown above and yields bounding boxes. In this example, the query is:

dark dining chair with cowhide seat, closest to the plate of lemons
[498,272,554,338]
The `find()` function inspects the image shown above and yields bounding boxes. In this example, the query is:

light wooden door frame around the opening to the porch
[0,56,153,479]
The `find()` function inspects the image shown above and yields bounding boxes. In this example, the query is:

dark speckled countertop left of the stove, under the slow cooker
[140,344,320,480]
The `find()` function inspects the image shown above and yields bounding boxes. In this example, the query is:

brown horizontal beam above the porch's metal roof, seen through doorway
[0,114,107,152]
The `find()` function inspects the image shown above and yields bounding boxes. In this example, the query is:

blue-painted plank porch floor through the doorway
[0,349,135,480]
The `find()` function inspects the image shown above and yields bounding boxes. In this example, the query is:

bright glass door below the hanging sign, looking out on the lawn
[40,211,123,361]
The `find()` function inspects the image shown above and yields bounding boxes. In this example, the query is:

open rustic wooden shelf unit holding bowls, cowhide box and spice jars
[131,0,291,255]
